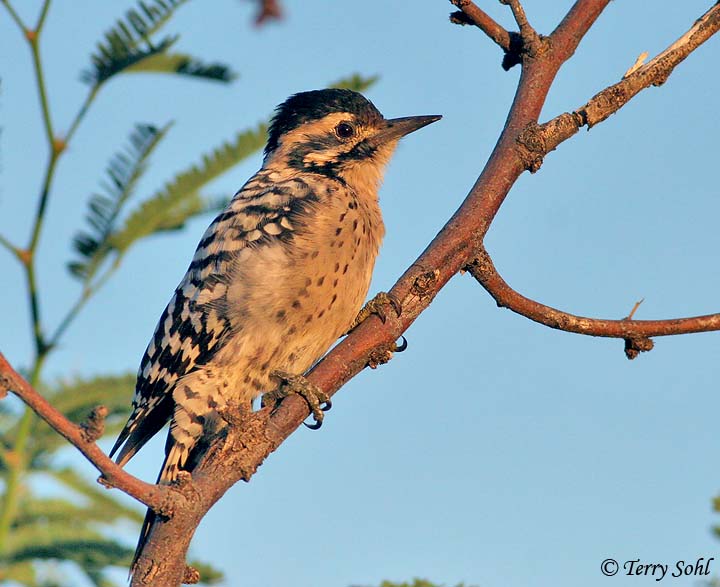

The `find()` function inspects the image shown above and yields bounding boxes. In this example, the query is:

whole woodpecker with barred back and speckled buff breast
[110,89,441,566]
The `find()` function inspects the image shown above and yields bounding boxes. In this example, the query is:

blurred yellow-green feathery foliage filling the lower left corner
[0,373,221,587]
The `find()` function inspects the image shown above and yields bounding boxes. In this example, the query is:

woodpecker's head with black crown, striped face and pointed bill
[265,89,441,193]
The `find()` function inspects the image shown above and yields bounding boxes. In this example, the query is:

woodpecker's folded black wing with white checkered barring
[110,172,316,465]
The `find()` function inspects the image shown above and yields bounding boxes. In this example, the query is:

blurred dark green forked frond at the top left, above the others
[81,0,235,86]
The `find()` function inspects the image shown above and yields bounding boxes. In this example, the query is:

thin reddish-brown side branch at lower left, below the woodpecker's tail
[0,353,179,512]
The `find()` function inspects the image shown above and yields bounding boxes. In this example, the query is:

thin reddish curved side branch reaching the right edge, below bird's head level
[467,248,720,340]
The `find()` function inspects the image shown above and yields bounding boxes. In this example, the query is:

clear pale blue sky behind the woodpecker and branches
[0,0,720,587]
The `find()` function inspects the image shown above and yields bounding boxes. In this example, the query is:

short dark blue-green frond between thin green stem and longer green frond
[68,124,170,282]
